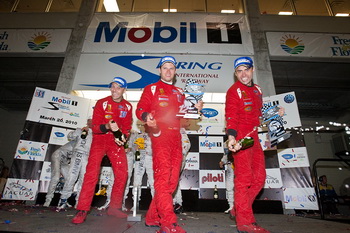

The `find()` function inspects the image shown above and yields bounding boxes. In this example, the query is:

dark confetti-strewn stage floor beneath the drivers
[0,202,350,233]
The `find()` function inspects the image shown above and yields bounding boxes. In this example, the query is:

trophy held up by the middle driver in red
[177,79,205,119]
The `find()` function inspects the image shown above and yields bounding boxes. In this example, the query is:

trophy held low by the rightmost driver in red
[262,105,291,147]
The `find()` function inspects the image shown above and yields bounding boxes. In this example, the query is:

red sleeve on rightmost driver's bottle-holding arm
[225,88,240,137]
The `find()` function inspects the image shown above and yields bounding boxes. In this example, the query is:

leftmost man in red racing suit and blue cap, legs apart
[72,77,132,224]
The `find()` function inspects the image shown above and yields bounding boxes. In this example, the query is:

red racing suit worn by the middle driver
[136,81,185,225]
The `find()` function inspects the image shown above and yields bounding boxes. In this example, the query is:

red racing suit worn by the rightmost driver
[225,81,266,226]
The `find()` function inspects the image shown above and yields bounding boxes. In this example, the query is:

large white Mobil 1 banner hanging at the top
[83,13,253,55]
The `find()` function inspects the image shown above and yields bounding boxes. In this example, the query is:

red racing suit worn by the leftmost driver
[77,96,132,210]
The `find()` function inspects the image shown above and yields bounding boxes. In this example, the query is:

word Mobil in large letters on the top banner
[94,22,197,43]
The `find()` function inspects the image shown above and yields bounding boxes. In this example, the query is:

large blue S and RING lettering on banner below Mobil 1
[80,55,222,89]
